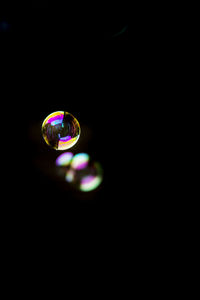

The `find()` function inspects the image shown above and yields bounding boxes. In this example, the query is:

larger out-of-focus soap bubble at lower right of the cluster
[65,153,103,192]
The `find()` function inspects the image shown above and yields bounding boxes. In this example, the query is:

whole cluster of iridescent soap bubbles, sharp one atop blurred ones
[42,111,103,192]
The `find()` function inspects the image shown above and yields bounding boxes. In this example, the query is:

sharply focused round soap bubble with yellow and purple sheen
[42,111,81,150]
